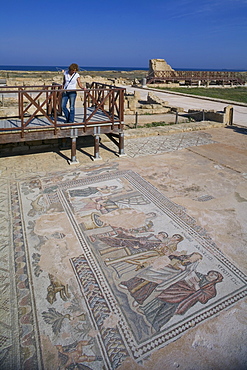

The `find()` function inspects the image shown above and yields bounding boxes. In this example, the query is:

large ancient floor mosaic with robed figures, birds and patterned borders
[0,168,246,370]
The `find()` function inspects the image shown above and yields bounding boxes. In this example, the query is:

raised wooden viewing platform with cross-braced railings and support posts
[0,82,125,163]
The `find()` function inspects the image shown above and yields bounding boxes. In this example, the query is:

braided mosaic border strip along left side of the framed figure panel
[58,191,131,368]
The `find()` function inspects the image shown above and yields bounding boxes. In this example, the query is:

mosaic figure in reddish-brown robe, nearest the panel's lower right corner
[139,270,223,331]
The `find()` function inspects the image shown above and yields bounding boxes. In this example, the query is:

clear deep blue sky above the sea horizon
[0,0,247,70]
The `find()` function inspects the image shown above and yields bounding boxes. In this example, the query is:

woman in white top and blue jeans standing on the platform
[62,63,83,122]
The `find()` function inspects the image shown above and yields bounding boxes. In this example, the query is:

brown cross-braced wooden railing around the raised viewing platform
[0,82,125,136]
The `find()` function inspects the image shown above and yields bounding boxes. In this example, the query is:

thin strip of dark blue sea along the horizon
[0,65,246,72]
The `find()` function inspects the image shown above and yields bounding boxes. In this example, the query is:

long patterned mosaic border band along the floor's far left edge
[0,182,41,369]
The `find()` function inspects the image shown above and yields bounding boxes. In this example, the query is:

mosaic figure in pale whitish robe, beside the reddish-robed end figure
[119,253,202,306]
